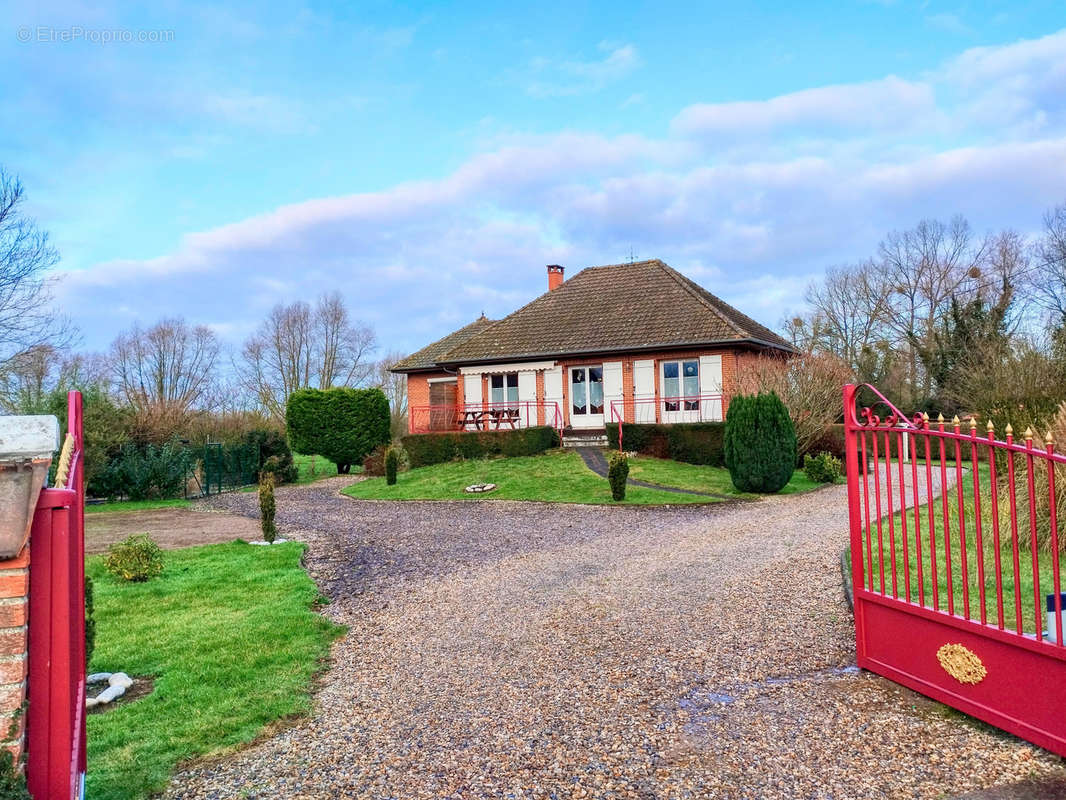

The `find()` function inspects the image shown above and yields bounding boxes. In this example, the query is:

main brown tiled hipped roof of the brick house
[437,259,793,364]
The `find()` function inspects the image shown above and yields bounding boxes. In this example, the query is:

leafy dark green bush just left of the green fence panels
[96,442,191,500]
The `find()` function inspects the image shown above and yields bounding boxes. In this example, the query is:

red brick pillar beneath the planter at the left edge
[0,545,30,761]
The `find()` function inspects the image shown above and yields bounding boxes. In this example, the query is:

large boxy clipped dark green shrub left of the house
[286,387,391,475]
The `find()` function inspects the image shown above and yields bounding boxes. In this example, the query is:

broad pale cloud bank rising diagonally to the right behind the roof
[60,28,1066,350]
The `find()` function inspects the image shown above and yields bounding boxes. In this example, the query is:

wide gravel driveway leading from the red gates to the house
[167,479,1066,800]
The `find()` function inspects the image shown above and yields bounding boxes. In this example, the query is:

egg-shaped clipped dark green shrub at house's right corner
[725,394,796,493]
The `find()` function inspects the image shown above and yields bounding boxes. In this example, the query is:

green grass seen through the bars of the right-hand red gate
[860,461,1066,633]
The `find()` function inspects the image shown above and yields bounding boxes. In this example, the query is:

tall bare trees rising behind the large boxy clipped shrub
[237,292,376,420]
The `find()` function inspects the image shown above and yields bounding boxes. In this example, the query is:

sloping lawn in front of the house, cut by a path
[343,450,806,506]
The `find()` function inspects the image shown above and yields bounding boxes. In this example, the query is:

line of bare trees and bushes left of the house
[0,171,406,488]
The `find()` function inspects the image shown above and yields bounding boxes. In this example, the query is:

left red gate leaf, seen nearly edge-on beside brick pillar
[26,391,85,800]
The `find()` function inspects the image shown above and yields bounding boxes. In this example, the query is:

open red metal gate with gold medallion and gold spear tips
[844,386,1066,755]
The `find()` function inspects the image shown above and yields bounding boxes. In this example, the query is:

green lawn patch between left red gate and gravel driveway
[86,542,340,800]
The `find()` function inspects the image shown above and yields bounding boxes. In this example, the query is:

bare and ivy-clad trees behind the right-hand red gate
[782,205,1066,430]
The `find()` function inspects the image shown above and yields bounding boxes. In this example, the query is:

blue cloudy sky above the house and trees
[6,0,1066,362]
